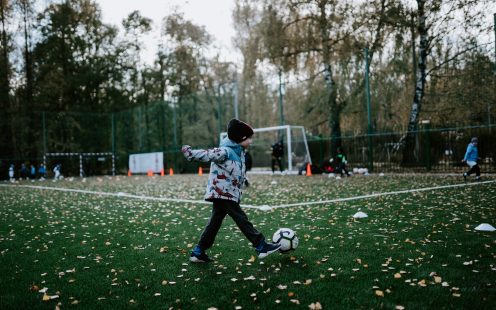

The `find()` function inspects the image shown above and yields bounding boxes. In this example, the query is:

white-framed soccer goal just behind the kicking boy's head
[220,125,312,173]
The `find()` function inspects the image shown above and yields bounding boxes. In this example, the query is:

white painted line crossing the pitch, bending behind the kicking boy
[0,180,496,211]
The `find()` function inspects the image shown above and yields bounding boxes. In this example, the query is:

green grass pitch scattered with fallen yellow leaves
[0,175,496,309]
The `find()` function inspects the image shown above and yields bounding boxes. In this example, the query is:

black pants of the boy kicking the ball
[198,199,265,251]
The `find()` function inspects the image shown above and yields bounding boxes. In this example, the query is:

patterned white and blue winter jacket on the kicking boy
[181,138,246,203]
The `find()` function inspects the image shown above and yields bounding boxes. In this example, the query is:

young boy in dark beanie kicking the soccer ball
[181,119,281,263]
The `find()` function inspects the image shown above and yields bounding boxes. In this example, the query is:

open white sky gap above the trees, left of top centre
[96,0,240,64]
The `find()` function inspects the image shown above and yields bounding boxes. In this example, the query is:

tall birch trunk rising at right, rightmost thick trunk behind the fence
[401,0,428,165]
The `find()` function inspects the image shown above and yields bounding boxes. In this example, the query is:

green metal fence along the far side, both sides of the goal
[0,104,496,179]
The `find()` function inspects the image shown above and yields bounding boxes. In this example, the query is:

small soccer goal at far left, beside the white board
[43,152,115,177]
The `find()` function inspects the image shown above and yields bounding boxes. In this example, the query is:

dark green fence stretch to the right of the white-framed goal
[309,125,496,173]
